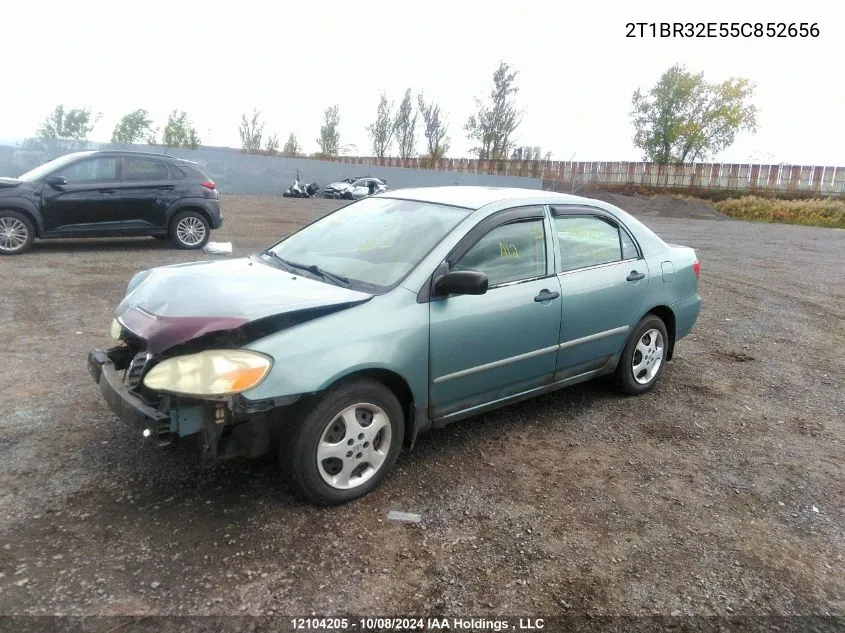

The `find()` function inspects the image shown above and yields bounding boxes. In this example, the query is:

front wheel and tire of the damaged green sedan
[279,379,405,506]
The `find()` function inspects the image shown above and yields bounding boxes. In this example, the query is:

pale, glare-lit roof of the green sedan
[378,185,591,209]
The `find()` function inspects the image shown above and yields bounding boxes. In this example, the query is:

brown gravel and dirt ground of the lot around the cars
[0,196,845,616]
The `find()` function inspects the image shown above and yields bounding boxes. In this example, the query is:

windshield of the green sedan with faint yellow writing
[270,198,471,292]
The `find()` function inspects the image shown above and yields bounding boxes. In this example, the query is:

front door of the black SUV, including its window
[42,156,122,232]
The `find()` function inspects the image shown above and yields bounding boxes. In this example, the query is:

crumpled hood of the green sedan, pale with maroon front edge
[115,257,372,354]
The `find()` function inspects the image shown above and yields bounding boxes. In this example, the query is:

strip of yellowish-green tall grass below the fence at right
[711,196,845,229]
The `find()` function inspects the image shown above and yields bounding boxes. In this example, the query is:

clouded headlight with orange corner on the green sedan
[144,349,273,396]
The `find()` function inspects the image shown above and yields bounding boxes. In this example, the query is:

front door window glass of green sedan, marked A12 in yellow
[452,219,546,286]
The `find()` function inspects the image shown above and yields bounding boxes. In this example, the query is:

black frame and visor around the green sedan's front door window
[417,204,556,303]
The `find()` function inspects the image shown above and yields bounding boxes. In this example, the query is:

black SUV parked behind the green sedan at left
[0,151,223,255]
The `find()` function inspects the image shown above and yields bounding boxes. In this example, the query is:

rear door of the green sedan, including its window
[551,206,649,381]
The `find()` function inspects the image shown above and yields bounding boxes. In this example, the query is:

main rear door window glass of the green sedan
[554,215,622,271]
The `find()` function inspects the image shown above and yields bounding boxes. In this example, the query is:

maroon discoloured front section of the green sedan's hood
[120,308,249,354]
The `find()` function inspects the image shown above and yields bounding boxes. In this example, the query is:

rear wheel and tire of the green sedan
[614,314,669,396]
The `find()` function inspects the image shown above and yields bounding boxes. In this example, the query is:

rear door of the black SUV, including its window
[120,156,179,231]
